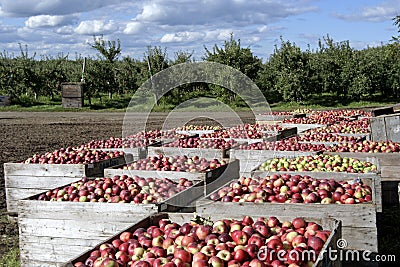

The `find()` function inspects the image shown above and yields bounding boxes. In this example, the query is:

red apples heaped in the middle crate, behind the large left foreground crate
[121,155,228,172]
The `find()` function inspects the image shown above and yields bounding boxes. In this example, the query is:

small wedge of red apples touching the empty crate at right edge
[309,118,370,134]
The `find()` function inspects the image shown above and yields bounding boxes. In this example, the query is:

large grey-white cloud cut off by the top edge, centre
[135,0,317,25]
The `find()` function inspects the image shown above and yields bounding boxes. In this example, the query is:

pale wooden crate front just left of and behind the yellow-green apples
[229,148,321,176]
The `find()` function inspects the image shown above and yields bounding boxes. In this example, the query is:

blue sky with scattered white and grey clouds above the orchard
[0,0,400,60]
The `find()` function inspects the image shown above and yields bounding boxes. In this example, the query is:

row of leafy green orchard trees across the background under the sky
[0,17,400,104]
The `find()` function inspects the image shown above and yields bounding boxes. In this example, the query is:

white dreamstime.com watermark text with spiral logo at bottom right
[257,239,396,263]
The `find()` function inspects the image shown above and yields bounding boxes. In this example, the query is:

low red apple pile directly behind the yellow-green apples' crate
[239,138,327,151]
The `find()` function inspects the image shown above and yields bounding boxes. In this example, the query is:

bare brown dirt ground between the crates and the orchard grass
[0,112,254,258]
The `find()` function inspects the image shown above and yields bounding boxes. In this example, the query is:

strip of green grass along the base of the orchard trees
[0,94,398,112]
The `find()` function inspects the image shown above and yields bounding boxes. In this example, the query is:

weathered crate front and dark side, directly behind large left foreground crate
[104,160,239,196]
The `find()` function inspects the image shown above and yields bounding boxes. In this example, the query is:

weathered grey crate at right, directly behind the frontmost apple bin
[196,172,381,252]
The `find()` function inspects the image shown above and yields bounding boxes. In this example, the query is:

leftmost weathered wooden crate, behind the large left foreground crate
[4,156,125,213]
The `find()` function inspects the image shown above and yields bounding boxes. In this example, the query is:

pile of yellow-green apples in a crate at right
[259,155,377,173]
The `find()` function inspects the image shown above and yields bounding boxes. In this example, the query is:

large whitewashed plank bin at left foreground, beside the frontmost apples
[18,180,203,266]
